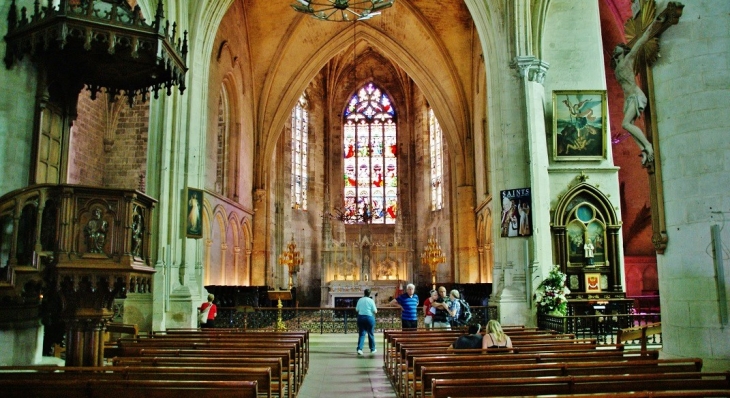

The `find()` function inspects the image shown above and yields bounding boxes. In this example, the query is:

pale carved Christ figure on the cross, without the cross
[611,12,663,165]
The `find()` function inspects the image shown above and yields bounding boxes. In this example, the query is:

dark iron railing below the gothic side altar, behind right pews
[537,314,662,346]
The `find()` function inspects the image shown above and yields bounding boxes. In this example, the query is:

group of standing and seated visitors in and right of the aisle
[355,283,512,355]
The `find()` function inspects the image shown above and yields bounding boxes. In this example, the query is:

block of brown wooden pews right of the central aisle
[383,327,730,398]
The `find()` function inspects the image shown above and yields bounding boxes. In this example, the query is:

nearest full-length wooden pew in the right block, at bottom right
[431,372,730,398]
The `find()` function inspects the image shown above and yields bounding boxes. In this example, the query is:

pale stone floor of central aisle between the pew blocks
[297,333,396,398]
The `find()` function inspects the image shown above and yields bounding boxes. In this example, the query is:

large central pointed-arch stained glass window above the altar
[343,83,398,224]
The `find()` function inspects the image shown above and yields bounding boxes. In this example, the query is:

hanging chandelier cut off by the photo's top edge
[291,0,395,22]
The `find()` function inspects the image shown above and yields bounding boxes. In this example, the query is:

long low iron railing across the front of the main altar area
[215,306,498,333]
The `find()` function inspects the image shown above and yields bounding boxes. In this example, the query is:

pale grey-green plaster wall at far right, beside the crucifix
[654,0,730,371]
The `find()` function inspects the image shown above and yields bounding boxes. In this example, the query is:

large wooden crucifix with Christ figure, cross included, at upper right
[611,0,684,254]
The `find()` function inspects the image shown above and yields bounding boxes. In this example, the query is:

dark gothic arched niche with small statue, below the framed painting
[551,182,623,294]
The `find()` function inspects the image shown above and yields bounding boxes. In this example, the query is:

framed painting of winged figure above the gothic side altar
[553,90,607,161]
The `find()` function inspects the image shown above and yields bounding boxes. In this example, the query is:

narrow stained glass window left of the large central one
[291,96,309,210]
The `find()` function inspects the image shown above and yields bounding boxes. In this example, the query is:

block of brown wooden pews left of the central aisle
[0,329,309,398]
